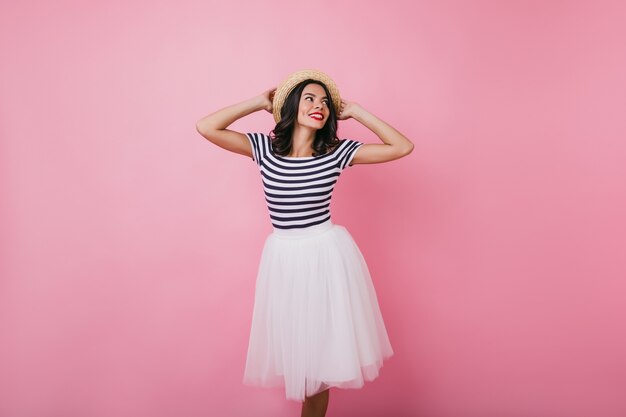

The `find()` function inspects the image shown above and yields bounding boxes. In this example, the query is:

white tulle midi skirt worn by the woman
[243,220,393,401]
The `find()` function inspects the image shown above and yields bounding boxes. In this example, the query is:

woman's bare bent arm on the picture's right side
[339,100,414,164]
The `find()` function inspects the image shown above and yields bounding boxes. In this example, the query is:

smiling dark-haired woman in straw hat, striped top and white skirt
[197,70,413,416]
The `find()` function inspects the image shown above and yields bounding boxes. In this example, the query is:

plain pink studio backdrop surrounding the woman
[0,0,626,417]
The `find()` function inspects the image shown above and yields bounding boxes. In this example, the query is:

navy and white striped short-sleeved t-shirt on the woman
[246,133,363,229]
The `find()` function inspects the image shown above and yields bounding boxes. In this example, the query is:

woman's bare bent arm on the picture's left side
[196,89,275,157]
